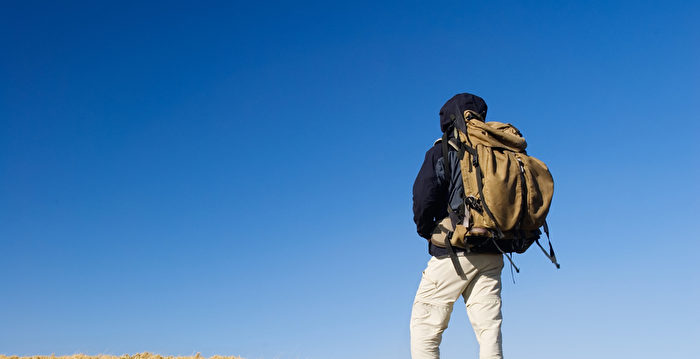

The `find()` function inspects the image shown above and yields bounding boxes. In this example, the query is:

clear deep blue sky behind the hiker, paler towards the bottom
[0,1,700,359]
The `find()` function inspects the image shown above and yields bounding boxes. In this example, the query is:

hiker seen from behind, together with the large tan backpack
[410,93,559,359]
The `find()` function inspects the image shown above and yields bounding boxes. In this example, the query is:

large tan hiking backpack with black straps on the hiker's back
[431,110,560,275]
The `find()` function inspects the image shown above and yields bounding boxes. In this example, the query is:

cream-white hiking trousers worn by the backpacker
[410,253,503,359]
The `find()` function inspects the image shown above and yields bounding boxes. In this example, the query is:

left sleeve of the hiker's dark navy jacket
[413,143,448,239]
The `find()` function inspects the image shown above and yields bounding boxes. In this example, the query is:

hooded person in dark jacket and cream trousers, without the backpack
[410,93,503,359]
